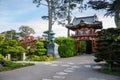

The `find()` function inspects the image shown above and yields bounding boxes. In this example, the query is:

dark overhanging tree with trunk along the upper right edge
[88,0,120,28]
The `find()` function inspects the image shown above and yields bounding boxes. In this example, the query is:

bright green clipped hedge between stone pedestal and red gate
[55,38,76,57]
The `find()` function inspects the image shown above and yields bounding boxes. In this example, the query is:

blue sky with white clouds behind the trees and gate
[0,0,116,37]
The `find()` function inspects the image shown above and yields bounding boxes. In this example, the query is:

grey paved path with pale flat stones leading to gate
[0,55,120,80]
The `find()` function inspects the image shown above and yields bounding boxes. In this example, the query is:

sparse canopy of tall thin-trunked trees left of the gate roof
[33,0,83,38]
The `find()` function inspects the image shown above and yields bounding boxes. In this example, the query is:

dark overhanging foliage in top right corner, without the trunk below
[88,0,120,15]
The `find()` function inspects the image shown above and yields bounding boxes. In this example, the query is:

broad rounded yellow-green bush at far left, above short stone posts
[0,40,25,60]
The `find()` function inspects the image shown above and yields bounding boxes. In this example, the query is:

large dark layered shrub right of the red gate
[95,28,120,67]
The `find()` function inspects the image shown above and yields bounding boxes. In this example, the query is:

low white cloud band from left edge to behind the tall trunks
[3,20,67,37]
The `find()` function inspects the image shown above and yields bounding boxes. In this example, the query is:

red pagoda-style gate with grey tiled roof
[66,15,102,53]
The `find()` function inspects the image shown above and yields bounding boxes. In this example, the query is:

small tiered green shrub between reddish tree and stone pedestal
[34,40,46,56]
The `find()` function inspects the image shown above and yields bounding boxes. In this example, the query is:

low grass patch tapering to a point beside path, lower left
[0,61,34,72]
